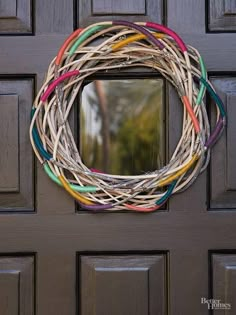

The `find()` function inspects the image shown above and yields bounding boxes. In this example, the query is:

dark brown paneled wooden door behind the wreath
[0,0,236,315]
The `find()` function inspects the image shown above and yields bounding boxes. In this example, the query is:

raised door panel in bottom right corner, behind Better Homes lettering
[211,253,236,315]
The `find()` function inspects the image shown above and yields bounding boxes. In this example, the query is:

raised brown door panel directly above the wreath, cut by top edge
[77,0,164,27]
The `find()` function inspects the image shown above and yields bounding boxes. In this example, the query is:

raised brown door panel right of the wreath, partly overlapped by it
[210,77,236,209]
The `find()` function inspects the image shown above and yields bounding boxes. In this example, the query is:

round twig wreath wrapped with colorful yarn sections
[30,21,226,212]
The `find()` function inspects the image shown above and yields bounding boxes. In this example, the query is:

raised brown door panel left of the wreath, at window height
[0,78,34,211]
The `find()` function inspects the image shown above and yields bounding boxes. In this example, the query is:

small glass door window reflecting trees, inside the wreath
[80,79,165,175]
